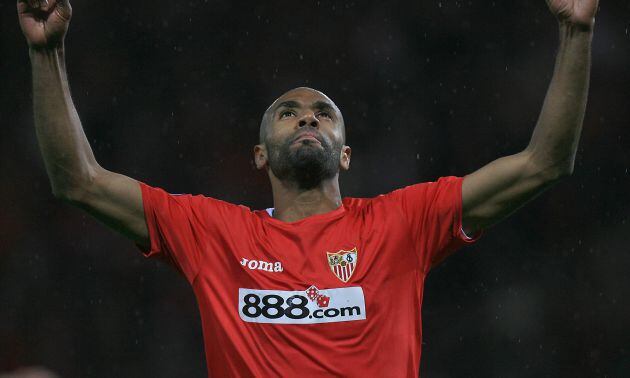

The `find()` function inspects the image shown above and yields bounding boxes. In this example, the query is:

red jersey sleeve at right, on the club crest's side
[390,176,483,271]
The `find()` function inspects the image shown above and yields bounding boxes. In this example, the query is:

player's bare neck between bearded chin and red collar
[270,174,341,222]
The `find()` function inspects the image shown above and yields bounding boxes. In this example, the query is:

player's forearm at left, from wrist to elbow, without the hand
[30,47,98,197]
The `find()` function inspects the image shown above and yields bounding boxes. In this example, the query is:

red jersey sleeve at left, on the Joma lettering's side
[139,182,236,283]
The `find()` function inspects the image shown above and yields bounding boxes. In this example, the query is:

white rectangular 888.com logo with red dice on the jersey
[238,285,366,324]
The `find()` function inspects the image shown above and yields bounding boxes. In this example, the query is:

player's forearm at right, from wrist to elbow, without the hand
[527,24,593,175]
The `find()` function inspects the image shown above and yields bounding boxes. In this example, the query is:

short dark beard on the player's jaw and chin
[266,131,342,190]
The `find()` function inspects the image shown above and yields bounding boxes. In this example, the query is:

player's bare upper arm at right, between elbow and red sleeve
[462,150,559,235]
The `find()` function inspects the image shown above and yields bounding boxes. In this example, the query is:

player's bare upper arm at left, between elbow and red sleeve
[71,167,149,247]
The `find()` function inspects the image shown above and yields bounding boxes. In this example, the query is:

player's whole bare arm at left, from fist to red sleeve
[17,0,148,246]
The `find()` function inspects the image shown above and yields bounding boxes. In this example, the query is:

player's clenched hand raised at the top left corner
[17,0,72,48]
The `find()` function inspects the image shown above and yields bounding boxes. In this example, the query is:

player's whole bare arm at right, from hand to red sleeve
[462,0,598,235]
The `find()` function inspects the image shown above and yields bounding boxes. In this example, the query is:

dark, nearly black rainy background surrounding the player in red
[0,0,630,378]
